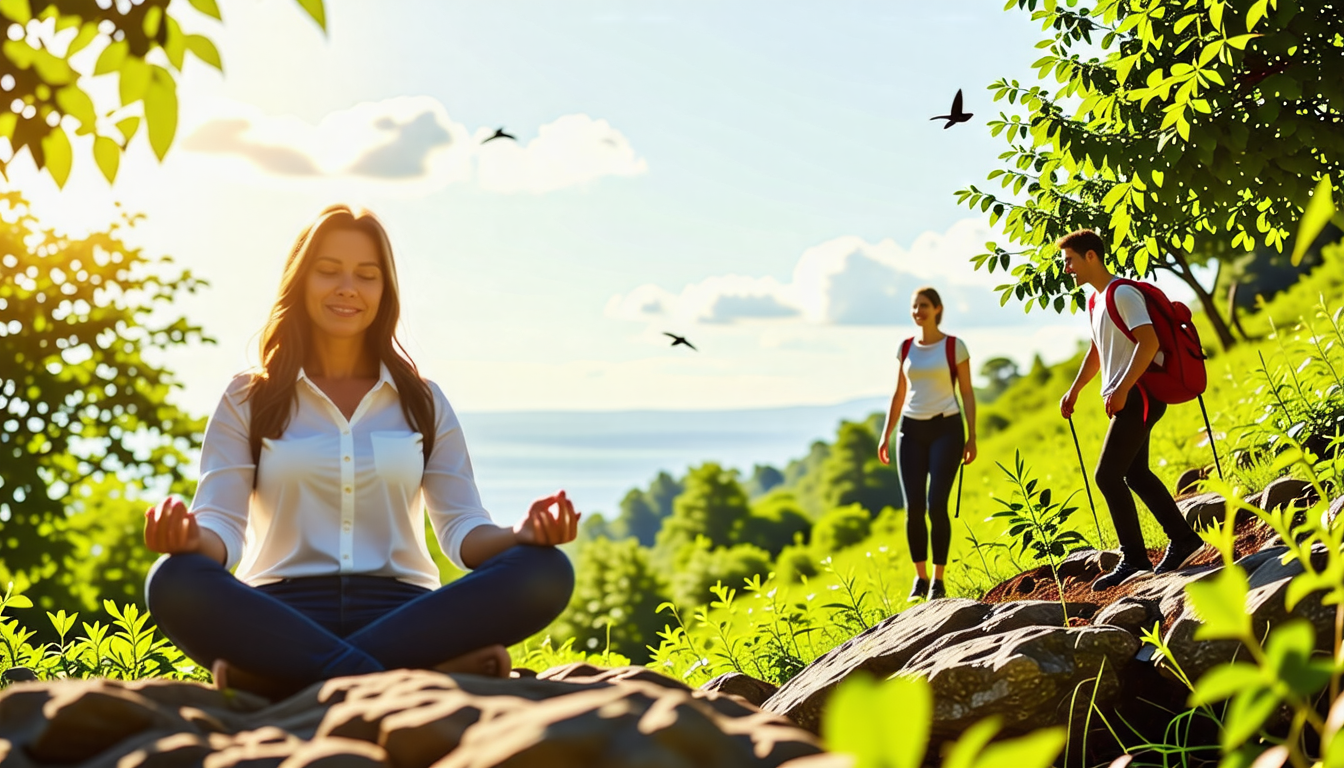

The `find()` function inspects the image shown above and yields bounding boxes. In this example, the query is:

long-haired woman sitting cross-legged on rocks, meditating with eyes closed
[145,206,579,698]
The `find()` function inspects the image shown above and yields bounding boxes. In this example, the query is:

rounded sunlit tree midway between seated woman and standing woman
[655,461,750,565]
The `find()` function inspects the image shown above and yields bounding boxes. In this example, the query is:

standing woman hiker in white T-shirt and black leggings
[878,286,976,600]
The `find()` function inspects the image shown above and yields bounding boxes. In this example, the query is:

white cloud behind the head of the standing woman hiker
[606,219,1027,327]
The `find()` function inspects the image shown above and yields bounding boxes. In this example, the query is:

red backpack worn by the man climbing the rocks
[1087,278,1208,404]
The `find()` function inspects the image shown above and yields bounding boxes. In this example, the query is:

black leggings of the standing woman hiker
[898,413,966,565]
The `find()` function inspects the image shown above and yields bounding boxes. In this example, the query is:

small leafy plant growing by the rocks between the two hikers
[989,451,1087,623]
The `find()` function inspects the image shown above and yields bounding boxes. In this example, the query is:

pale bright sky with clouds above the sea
[11,0,1193,412]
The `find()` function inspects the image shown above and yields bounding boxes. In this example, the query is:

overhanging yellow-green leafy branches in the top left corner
[0,0,327,186]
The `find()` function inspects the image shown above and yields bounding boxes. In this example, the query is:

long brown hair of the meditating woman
[247,206,434,476]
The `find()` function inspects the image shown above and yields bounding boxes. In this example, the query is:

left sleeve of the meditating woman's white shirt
[191,374,257,570]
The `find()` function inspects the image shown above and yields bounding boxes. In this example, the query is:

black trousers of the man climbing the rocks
[1095,387,1195,568]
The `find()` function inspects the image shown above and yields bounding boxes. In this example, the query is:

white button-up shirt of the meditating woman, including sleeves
[191,366,492,589]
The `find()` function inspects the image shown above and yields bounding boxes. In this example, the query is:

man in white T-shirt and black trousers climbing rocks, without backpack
[1055,230,1203,590]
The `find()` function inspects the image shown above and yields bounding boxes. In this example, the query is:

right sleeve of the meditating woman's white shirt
[421,382,495,570]
